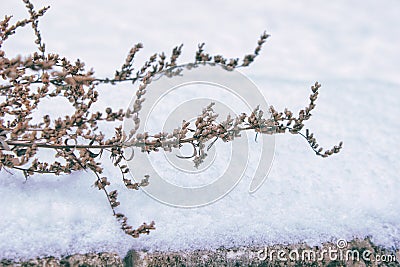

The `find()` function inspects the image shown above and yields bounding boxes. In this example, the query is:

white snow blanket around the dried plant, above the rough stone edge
[0,0,400,258]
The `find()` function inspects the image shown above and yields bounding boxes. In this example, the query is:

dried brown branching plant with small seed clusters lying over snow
[0,0,342,238]
